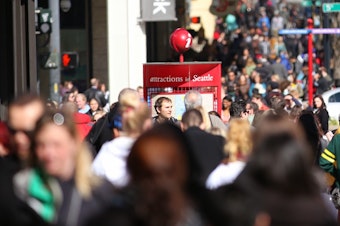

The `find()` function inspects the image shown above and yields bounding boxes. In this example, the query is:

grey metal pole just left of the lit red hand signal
[48,0,60,102]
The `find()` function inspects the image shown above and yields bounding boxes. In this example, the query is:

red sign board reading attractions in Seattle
[143,62,221,112]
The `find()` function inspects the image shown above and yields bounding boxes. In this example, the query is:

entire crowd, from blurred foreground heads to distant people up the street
[0,0,340,226]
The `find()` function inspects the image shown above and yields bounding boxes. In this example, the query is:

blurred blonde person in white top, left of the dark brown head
[92,91,152,187]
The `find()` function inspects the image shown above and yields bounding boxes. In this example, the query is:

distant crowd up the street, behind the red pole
[185,0,338,106]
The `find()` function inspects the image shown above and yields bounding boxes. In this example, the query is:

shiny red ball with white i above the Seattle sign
[170,28,192,53]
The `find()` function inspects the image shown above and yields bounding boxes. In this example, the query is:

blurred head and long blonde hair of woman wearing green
[33,110,98,197]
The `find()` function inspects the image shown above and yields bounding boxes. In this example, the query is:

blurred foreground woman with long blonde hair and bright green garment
[14,110,112,226]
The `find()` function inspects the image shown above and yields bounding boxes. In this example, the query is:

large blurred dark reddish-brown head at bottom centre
[127,124,194,187]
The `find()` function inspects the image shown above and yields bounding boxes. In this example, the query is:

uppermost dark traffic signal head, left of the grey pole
[35,8,52,34]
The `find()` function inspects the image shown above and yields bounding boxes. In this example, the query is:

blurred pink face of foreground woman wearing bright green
[35,123,77,180]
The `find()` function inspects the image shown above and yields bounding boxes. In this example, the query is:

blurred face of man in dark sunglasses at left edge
[8,101,44,160]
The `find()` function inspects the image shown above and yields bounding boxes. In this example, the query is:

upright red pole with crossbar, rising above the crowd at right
[307,18,313,107]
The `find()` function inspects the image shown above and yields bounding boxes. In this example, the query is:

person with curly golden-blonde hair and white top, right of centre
[206,118,252,189]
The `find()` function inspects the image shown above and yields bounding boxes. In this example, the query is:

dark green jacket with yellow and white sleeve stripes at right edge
[319,134,340,187]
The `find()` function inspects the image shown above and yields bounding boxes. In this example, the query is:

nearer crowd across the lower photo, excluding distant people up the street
[0,79,340,226]
